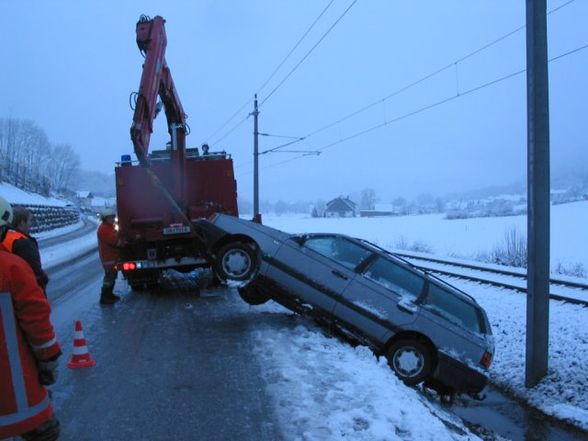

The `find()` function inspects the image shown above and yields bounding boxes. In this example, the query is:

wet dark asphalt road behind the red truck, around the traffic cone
[46,261,280,441]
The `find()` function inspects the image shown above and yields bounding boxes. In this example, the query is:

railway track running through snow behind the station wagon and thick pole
[394,251,588,306]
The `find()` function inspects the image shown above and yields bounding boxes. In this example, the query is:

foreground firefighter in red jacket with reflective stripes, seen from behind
[0,197,61,441]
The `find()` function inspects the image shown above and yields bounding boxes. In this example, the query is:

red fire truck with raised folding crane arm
[115,16,238,289]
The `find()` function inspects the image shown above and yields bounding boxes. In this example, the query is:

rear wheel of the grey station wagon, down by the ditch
[386,340,432,386]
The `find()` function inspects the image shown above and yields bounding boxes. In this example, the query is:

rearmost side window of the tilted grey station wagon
[423,283,486,333]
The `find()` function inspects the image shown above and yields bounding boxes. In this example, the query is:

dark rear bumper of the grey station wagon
[433,352,488,394]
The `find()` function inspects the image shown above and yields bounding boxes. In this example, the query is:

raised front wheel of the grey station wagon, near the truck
[215,242,258,282]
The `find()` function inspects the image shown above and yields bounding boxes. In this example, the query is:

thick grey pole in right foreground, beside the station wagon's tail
[525,0,550,387]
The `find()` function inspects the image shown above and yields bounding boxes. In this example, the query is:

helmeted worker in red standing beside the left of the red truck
[97,209,121,305]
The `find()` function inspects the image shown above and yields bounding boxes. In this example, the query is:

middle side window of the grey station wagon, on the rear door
[364,257,425,299]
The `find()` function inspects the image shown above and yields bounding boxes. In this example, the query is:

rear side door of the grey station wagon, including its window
[334,254,425,343]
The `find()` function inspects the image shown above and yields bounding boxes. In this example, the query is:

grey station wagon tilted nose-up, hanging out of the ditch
[199,214,494,394]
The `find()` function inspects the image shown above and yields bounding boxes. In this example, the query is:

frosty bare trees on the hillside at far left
[0,118,80,196]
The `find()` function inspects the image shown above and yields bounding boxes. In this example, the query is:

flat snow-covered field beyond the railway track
[263,201,588,276]
